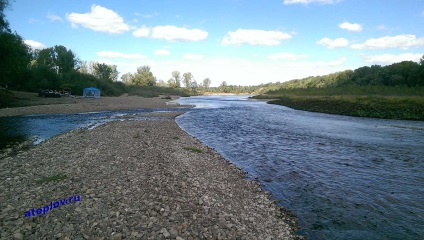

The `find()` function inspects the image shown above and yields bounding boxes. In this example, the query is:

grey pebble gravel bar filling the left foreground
[0,112,298,240]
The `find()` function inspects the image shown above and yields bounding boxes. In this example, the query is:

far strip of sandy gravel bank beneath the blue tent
[0,94,186,117]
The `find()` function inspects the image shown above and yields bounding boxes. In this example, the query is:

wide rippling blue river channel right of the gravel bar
[177,96,424,239]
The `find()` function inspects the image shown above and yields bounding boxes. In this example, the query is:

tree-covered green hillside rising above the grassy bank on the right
[257,56,424,96]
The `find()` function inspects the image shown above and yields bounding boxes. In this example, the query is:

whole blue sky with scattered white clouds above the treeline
[6,0,424,86]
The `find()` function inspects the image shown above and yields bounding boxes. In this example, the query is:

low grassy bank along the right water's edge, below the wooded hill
[268,95,424,120]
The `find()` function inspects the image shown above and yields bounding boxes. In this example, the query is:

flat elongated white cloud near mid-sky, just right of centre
[222,29,292,46]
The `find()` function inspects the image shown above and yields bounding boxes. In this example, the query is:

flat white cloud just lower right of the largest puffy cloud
[133,25,208,42]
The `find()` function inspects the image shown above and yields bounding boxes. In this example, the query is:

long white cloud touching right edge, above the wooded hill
[351,34,424,50]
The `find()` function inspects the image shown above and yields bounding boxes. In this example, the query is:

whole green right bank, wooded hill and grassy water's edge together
[255,56,424,120]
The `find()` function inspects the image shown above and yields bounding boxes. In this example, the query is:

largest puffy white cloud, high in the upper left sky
[67,5,130,34]
